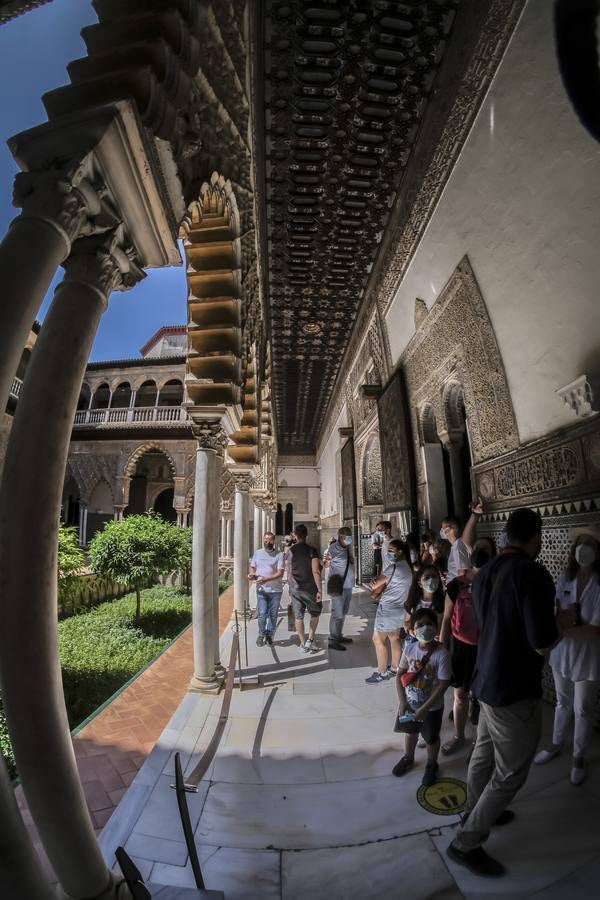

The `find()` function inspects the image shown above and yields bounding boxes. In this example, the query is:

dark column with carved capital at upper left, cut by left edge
[0,171,100,409]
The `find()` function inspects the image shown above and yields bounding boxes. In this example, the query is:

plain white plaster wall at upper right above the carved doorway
[387,0,600,442]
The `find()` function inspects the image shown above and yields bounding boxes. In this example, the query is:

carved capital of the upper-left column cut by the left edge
[13,154,105,258]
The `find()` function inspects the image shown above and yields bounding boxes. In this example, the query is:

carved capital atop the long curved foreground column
[62,226,146,303]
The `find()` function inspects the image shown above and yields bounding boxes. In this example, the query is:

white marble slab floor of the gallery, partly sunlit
[100,590,600,900]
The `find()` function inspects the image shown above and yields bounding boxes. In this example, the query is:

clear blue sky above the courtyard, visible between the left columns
[0,0,186,360]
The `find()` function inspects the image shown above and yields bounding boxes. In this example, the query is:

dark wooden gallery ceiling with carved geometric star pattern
[263,0,457,452]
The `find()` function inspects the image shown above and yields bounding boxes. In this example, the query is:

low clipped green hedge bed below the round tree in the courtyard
[0,587,192,775]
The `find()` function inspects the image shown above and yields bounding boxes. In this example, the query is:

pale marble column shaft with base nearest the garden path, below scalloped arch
[190,437,219,693]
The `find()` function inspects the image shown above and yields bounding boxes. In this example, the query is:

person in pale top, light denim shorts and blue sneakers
[365,538,412,684]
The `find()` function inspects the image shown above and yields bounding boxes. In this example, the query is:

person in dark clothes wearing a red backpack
[440,538,496,756]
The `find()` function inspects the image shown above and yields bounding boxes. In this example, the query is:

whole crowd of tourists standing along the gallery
[248,500,600,877]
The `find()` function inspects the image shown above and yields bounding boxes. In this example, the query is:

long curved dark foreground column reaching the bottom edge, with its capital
[0,235,142,900]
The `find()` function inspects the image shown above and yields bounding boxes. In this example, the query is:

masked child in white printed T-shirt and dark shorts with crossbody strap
[392,607,452,787]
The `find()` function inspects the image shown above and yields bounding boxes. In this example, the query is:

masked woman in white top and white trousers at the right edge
[535,525,600,785]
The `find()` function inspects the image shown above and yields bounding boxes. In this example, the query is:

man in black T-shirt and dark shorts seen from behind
[287,524,322,653]
